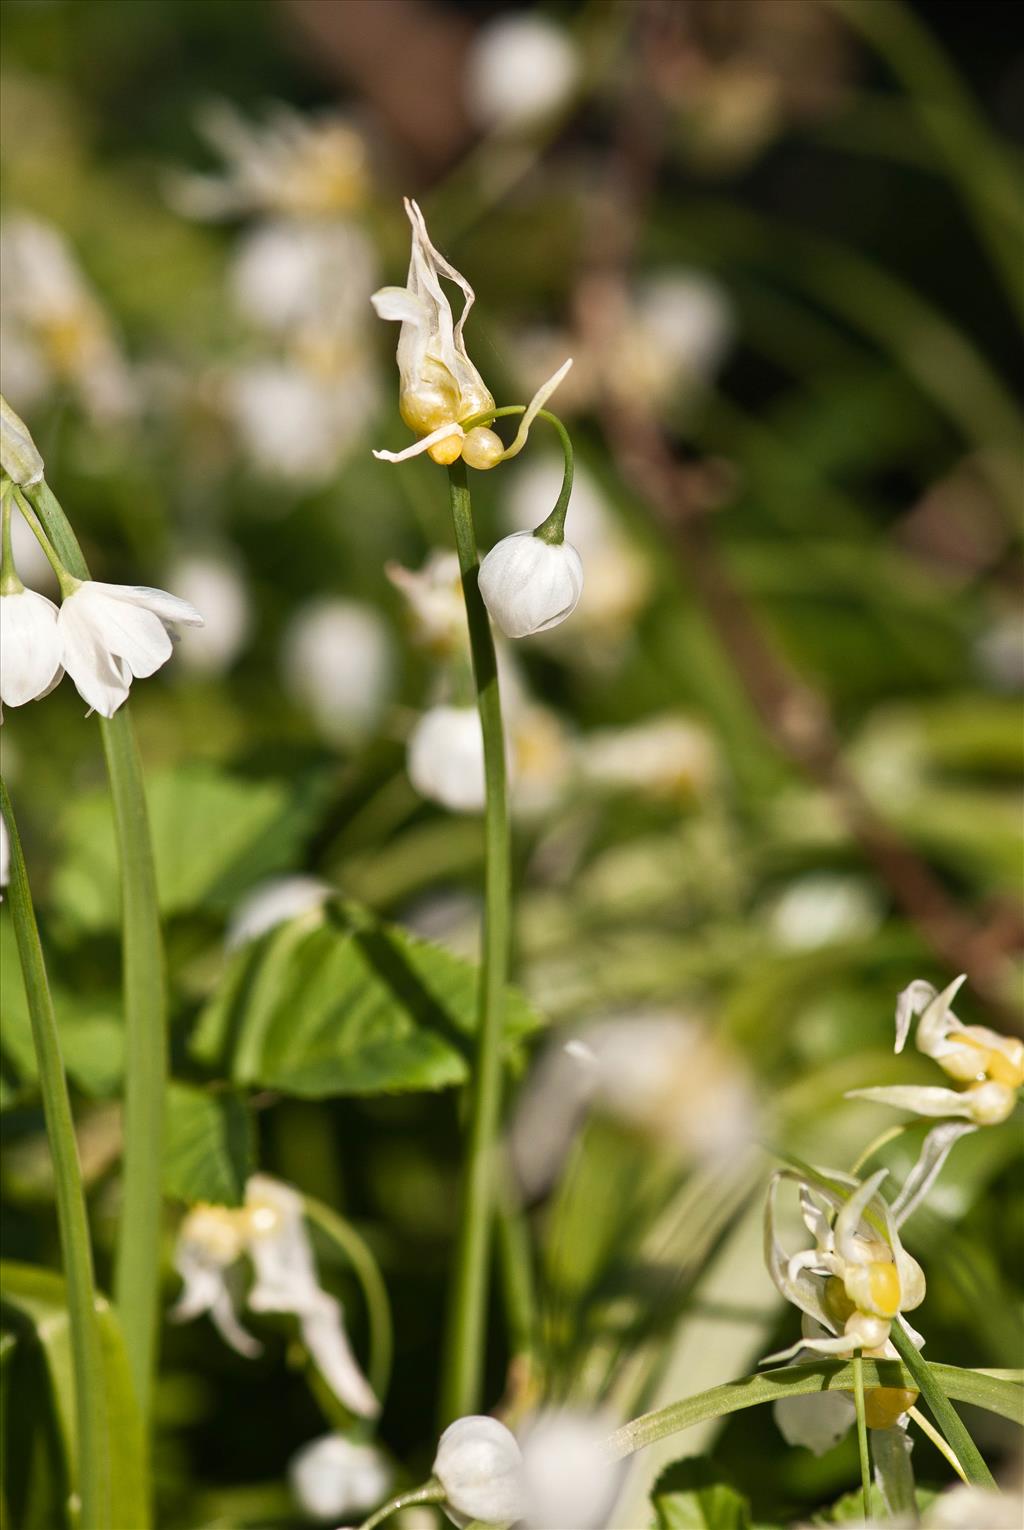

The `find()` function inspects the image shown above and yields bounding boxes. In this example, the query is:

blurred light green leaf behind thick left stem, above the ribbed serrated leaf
[54,763,323,930]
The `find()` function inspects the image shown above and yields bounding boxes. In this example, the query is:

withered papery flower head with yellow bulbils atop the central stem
[372,197,571,468]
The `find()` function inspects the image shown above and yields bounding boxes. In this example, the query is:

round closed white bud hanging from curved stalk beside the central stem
[479,531,583,638]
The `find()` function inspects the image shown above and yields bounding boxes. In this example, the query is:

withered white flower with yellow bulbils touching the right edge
[846,976,1024,1126]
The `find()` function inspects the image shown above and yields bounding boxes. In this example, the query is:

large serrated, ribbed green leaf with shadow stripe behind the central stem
[193,906,542,1099]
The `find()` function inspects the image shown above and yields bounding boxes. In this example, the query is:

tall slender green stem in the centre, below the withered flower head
[441,461,511,1424]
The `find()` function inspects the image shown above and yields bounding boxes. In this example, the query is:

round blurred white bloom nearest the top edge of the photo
[465,14,580,132]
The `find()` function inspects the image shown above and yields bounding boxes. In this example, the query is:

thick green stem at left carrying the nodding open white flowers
[23,482,167,1426]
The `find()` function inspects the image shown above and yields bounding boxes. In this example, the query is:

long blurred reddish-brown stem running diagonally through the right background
[577,0,1024,1028]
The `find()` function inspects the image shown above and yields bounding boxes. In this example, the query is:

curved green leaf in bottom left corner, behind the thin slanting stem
[0,1262,150,1530]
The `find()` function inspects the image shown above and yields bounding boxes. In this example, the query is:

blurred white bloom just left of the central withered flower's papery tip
[230,219,377,340]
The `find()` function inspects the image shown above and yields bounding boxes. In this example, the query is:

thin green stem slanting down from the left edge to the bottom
[0,780,110,1530]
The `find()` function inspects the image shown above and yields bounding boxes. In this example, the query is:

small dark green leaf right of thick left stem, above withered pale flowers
[164,1083,254,1206]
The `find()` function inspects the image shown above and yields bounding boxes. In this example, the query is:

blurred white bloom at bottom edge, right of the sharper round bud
[519,1409,623,1530]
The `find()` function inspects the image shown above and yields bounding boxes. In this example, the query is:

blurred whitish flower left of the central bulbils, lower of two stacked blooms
[222,352,378,483]
